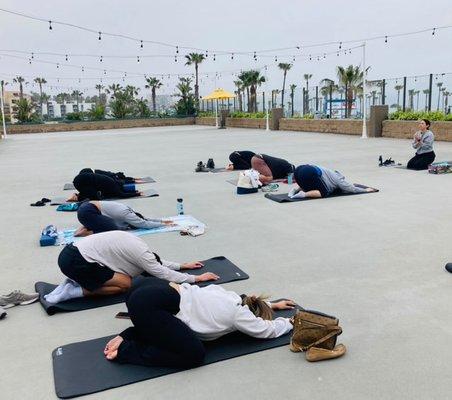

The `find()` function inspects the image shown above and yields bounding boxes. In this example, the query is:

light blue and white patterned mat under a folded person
[50,215,206,246]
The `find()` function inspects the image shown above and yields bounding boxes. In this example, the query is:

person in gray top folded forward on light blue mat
[74,201,175,236]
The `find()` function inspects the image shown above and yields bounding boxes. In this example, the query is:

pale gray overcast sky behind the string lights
[0,0,452,101]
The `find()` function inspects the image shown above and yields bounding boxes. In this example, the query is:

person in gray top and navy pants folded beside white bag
[288,165,376,199]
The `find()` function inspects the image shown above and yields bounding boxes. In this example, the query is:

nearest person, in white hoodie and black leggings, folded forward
[104,279,295,368]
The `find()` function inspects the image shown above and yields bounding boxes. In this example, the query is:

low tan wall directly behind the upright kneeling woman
[382,120,452,142]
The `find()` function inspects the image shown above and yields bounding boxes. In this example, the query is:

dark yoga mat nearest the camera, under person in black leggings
[52,302,296,399]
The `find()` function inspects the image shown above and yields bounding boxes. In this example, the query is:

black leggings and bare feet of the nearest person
[104,278,205,368]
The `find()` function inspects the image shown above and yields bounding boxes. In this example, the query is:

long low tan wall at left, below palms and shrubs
[7,117,195,134]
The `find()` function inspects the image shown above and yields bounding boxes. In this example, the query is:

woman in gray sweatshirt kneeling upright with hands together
[406,119,436,171]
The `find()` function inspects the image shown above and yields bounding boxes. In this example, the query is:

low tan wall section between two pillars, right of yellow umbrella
[279,118,363,135]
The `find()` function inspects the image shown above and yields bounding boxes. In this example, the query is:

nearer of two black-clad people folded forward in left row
[68,173,141,201]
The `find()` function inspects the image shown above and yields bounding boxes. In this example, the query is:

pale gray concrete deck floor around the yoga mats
[0,126,452,400]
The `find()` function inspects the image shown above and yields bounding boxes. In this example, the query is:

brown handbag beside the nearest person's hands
[290,309,342,352]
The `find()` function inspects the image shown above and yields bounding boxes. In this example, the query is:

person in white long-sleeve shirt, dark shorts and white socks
[45,231,219,303]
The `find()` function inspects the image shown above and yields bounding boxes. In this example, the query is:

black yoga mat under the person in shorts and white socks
[35,256,249,315]
